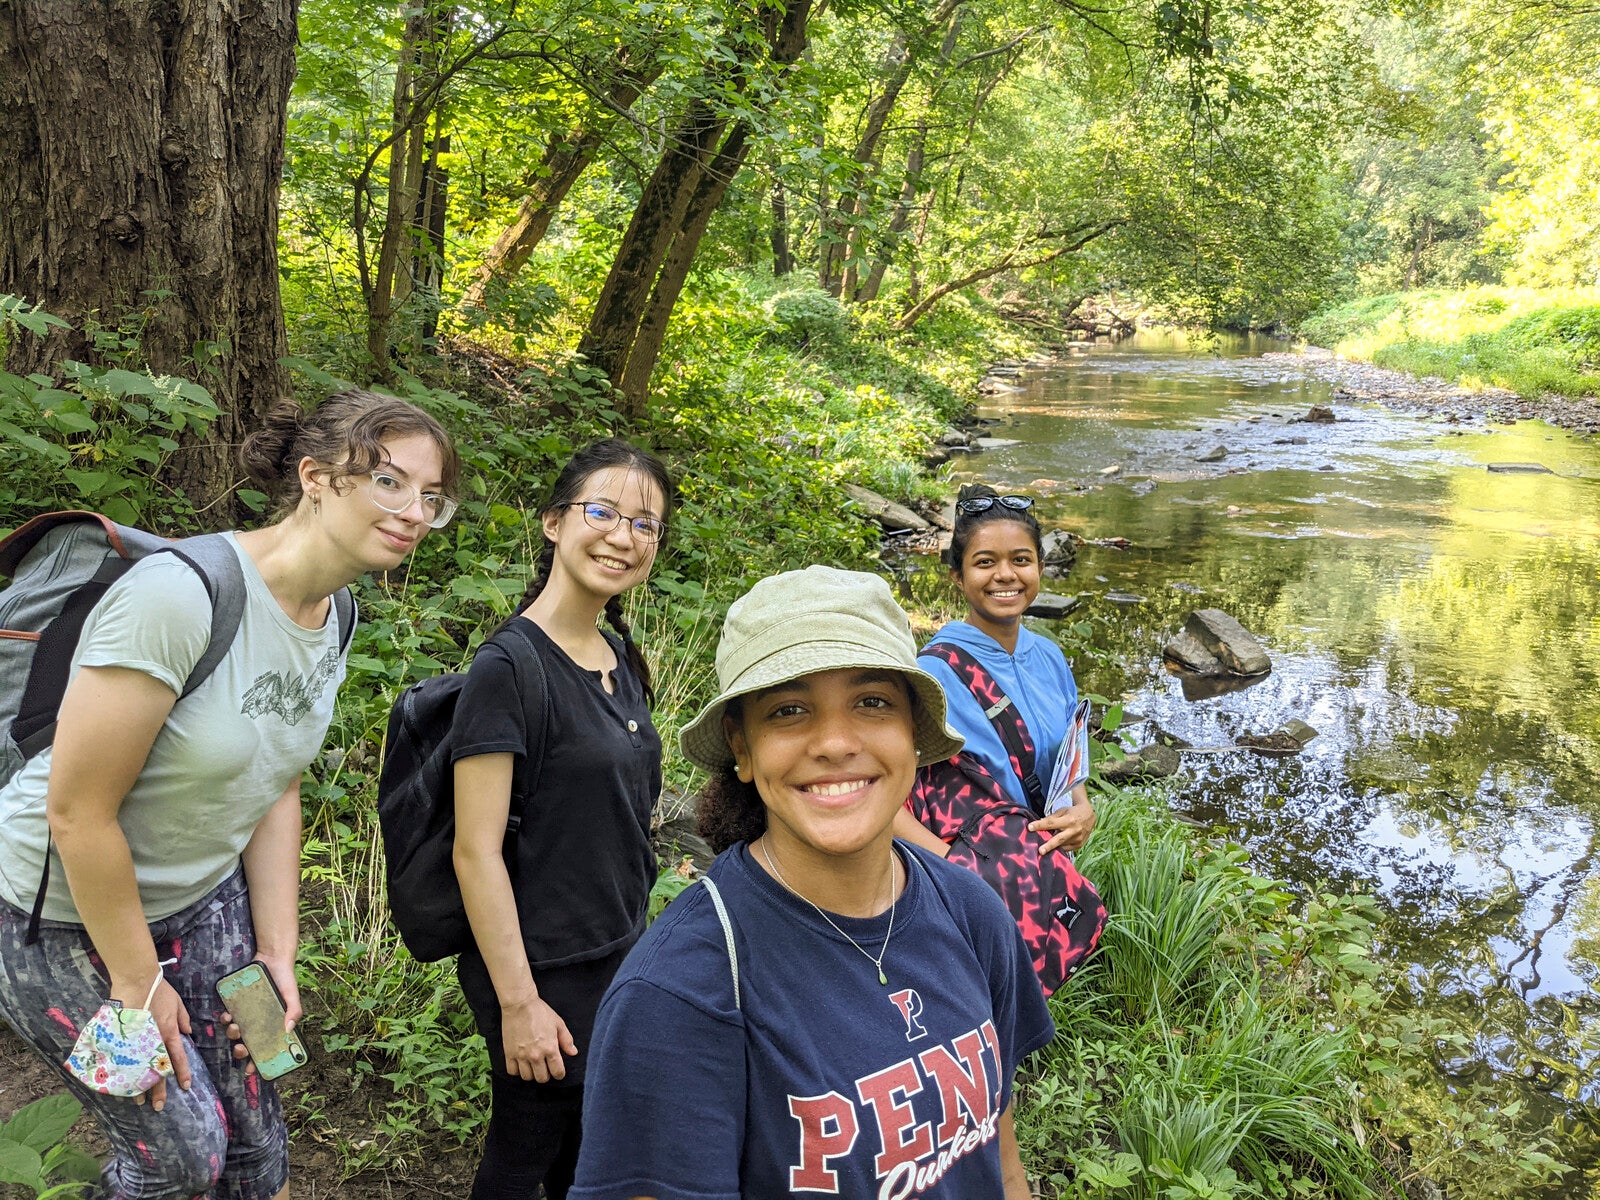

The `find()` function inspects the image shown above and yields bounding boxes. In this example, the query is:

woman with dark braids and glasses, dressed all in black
[454,438,675,1200]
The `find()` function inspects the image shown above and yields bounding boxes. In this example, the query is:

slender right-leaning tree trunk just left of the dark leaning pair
[461,51,666,309]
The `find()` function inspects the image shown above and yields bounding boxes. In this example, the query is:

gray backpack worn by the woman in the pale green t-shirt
[0,512,355,942]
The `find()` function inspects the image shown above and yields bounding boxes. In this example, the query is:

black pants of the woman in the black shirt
[456,949,627,1200]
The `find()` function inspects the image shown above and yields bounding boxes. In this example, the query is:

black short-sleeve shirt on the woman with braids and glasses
[453,618,661,968]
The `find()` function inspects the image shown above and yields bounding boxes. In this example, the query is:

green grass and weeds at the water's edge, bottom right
[1016,789,1566,1200]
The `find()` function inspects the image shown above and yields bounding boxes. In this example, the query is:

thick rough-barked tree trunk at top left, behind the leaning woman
[0,0,296,520]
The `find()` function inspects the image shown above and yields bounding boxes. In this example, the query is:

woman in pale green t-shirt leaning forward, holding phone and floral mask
[0,392,459,1200]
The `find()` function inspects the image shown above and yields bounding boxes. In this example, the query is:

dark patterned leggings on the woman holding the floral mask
[0,870,290,1200]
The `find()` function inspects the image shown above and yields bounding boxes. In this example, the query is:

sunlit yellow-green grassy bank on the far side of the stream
[1301,286,1600,397]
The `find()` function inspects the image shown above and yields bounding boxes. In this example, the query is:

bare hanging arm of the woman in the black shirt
[453,754,578,1083]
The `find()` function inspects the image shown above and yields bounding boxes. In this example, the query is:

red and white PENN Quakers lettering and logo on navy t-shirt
[789,1017,1002,1200]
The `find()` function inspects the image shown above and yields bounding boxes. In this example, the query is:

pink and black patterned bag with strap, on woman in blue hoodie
[907,642,1106,995]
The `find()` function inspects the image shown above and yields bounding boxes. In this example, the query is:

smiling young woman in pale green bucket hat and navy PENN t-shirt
[570,566,1054,1200]
